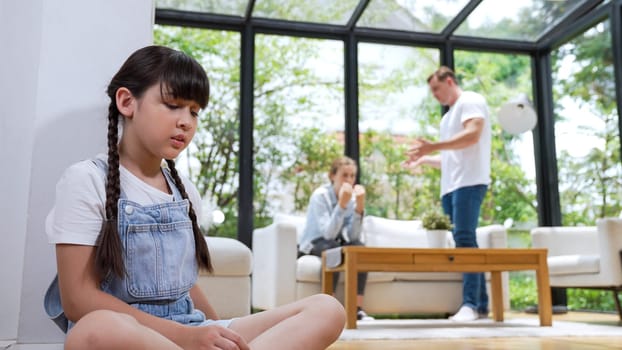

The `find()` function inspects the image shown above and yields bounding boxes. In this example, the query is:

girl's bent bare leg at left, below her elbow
[65,310,181,350]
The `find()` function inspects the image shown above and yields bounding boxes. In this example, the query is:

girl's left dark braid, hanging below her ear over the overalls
[95,102,125,278]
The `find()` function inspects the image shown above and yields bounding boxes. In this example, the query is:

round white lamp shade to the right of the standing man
[499,94,538,135]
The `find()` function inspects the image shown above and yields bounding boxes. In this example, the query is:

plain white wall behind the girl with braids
[0,0,154,343]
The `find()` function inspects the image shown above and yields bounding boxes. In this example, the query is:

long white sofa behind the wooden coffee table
[252,215,509,314]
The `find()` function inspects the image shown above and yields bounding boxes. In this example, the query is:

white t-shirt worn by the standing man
[440,91,491,196]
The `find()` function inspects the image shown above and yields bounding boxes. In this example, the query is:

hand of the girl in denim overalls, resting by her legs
[180,325,250,350]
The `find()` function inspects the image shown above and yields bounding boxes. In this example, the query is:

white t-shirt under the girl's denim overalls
[45,154,201,246]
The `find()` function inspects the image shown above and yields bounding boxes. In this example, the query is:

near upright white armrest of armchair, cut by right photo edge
[596,218,622,286]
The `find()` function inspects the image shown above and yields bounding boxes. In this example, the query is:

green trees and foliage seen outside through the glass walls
[154,0,622,252]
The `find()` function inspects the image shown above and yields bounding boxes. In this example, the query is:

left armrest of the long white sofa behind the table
[252,222,298,310]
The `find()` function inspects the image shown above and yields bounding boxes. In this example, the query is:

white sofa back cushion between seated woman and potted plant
[363,216,428,248]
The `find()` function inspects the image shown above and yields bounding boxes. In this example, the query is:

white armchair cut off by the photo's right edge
[531,218,622,319]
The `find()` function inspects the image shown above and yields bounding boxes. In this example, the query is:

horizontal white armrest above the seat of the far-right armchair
[531,226,599,256]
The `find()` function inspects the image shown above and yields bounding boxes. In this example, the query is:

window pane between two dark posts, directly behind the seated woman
[254,35,344,227]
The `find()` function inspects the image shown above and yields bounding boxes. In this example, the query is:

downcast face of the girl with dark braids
[119,84,200,160]
